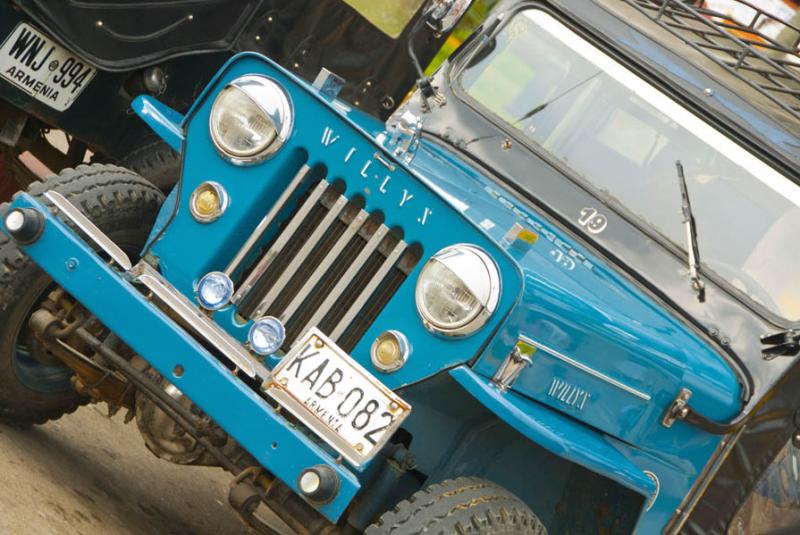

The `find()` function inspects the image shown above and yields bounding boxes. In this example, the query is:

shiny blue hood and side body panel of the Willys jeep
[413,139,741,533]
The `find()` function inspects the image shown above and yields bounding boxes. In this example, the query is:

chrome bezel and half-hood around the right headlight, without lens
[415,243,502,337]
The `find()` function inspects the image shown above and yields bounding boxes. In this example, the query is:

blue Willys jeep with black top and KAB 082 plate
[0,0,800,534]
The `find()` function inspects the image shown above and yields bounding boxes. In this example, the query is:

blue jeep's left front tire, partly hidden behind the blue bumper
[0,164,163,426]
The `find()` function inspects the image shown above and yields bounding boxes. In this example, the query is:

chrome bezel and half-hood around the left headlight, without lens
[209,74,294,165]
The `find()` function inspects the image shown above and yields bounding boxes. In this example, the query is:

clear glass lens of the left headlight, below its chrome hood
[211,86,277,158]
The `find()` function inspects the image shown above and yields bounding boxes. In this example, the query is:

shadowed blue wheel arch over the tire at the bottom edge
[382,367,655,533]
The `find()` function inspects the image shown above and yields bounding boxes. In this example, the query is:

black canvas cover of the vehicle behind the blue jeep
[16,0,447,117]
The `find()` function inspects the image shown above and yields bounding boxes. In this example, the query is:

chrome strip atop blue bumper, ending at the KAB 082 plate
[131,262,270,380]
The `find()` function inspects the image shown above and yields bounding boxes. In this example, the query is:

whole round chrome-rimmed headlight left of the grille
[209,75,294,165]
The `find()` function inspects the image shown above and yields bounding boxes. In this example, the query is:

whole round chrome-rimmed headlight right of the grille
[416,244,500,336]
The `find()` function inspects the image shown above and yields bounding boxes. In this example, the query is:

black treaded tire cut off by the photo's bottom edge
[364,477,547,535]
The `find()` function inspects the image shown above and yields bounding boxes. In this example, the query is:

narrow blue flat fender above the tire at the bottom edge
[450,367,656,496]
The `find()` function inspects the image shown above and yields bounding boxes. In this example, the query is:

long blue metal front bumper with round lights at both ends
[3,193,360,522]
